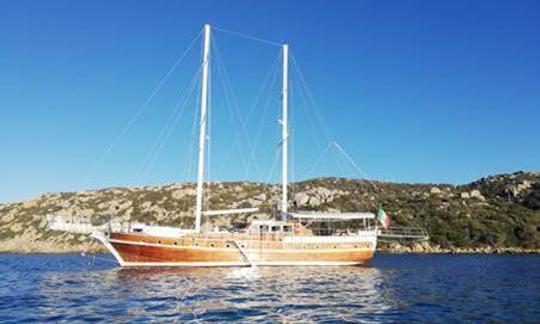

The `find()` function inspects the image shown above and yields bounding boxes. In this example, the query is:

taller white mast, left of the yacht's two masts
[195,24,210,233]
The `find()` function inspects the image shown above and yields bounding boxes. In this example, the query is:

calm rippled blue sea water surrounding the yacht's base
[0,254,540,322]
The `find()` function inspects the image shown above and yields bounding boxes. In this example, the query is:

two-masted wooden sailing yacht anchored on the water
[92,25,380,267]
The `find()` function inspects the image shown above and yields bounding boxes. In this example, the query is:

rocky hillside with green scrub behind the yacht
[0,172,540,252]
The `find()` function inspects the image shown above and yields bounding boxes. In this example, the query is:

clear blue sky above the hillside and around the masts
[0,0,540,201]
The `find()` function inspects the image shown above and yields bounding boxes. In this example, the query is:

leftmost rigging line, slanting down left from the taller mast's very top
[86,30,202,185]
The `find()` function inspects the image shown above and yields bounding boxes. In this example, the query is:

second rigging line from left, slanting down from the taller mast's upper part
[137,68,201,183]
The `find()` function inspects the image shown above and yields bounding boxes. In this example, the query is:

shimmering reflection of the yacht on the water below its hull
[112,267,392,321]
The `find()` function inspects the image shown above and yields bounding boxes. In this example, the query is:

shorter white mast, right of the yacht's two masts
[281,44,289,214]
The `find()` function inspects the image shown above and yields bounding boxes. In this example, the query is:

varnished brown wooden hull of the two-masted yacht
[95,233,375,266]
